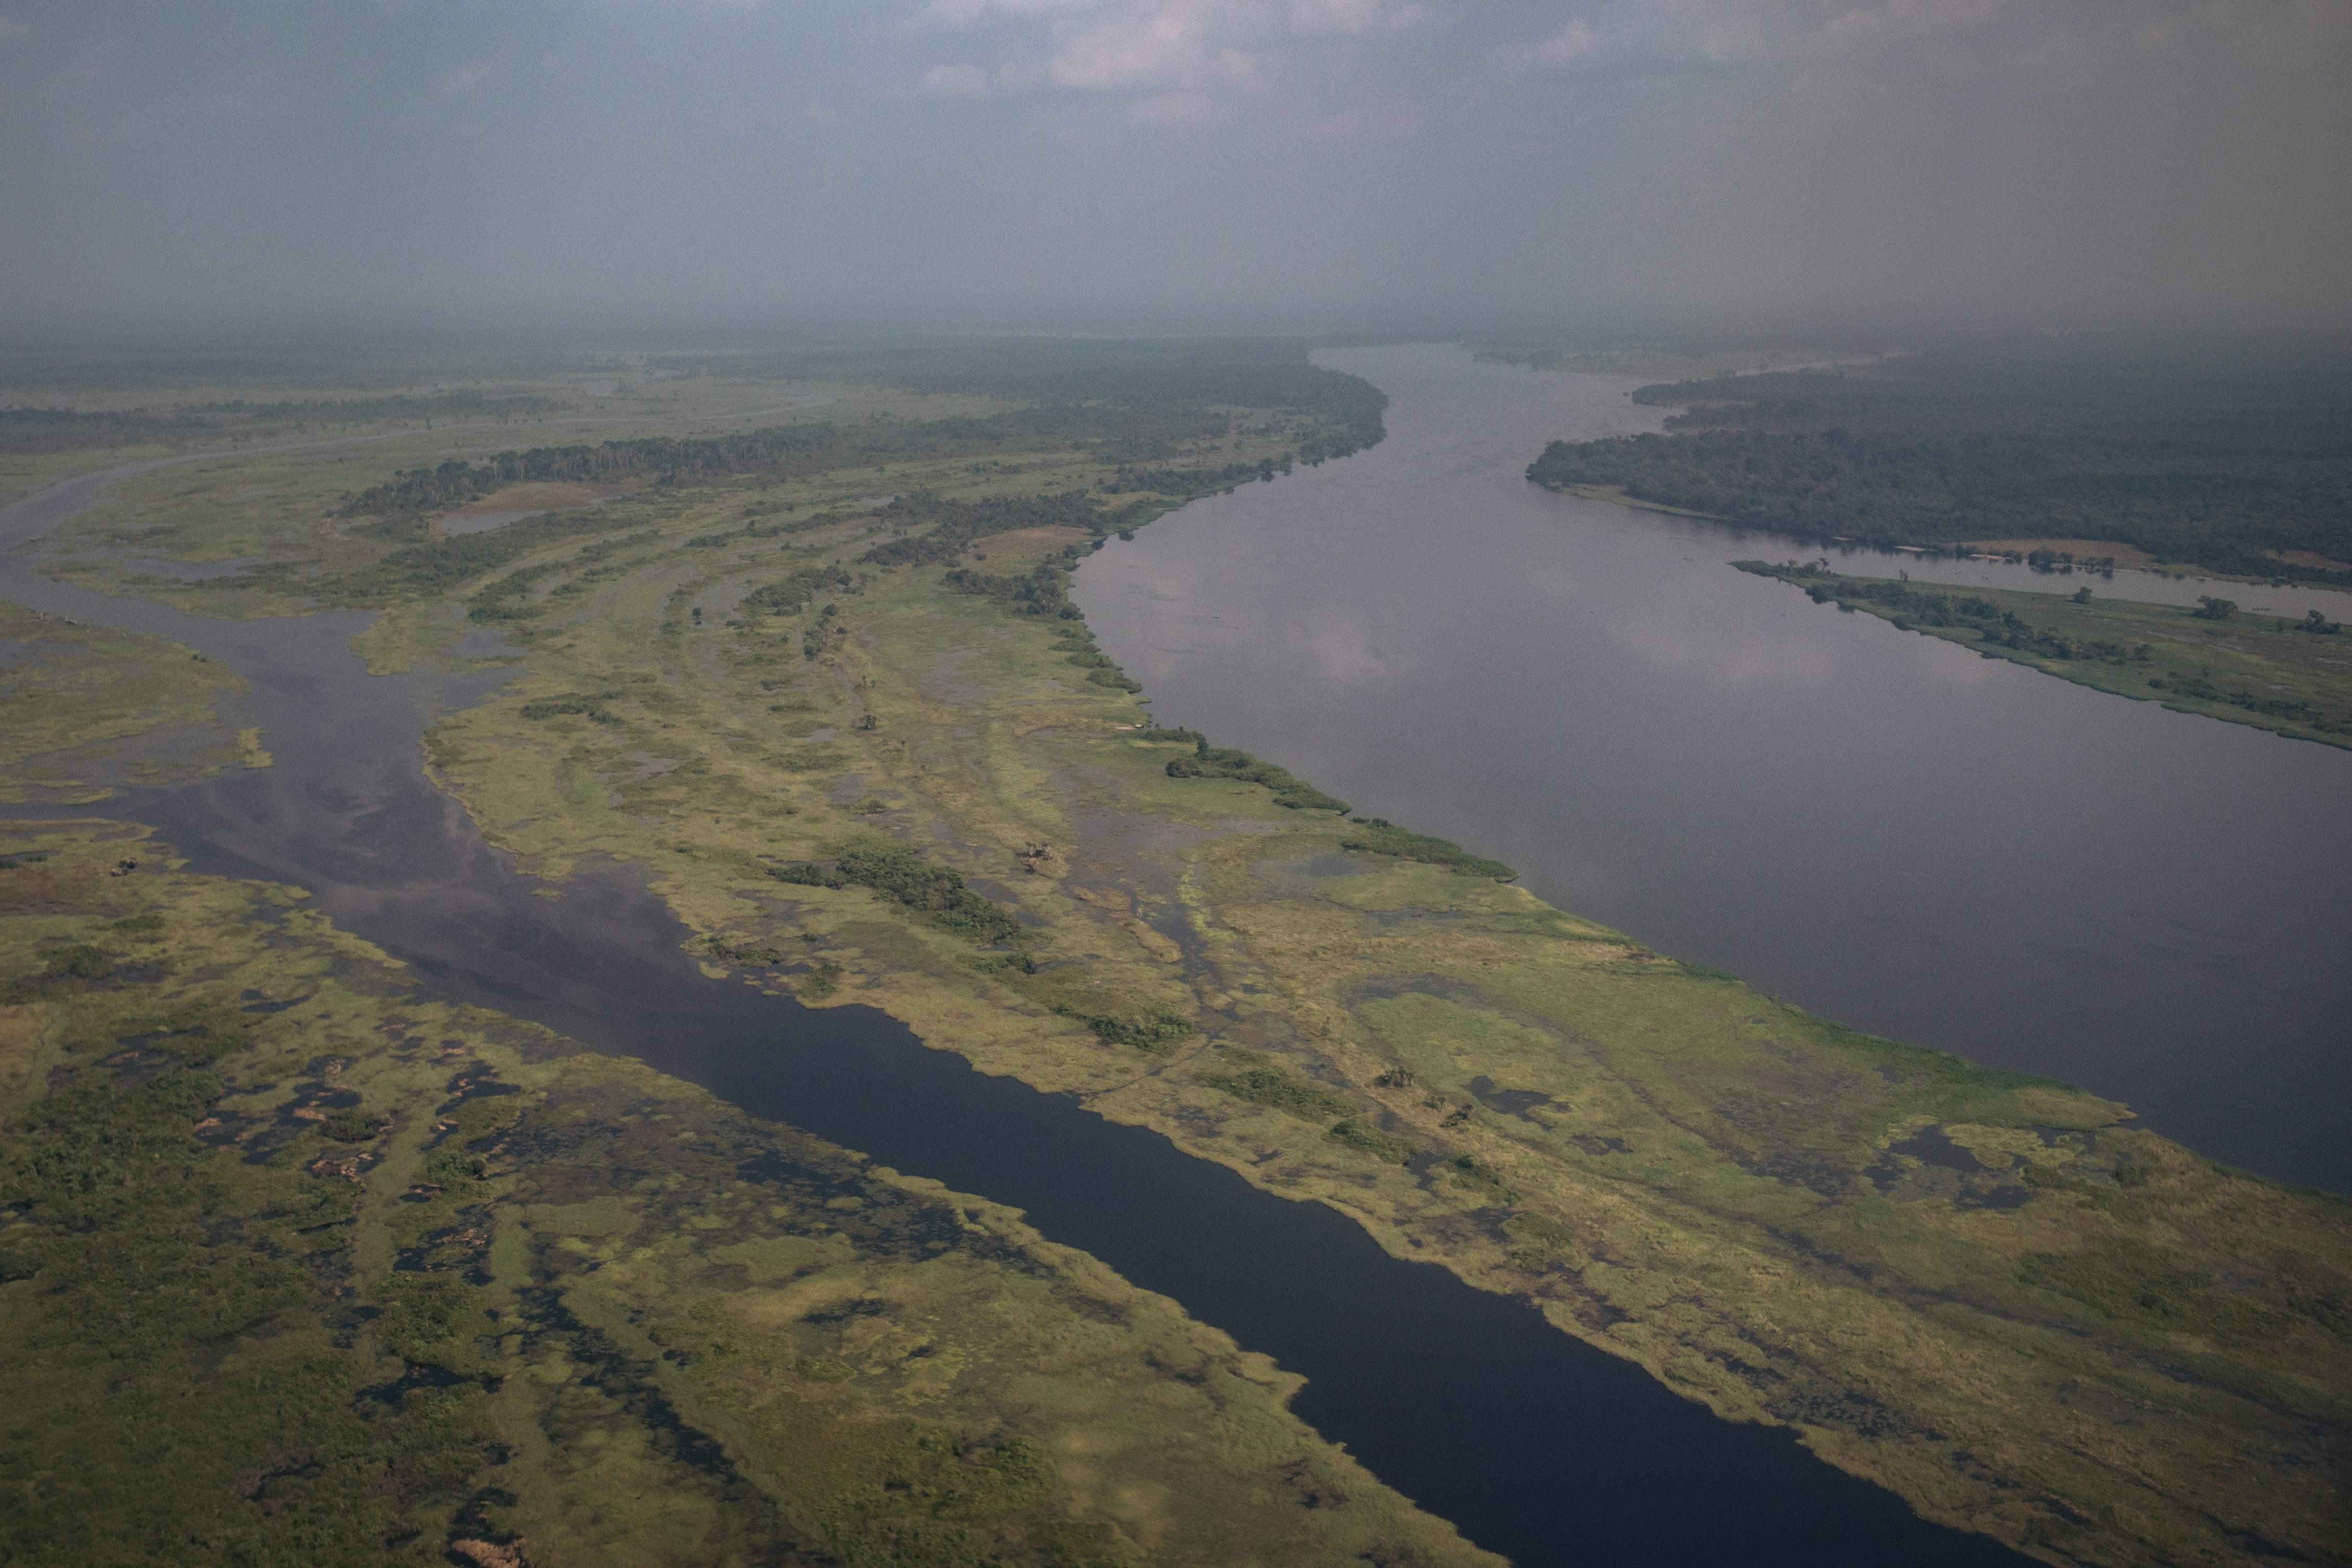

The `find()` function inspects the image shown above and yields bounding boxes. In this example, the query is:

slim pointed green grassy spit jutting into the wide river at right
[1738,562,2352,747]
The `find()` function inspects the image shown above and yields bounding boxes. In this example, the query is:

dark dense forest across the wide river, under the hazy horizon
[1527,336,2352,583]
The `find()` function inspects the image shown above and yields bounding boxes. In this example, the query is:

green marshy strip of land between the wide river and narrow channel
[18,352,2352,1563]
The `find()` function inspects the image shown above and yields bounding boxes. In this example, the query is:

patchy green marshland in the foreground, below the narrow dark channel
[0,672,1496,1568]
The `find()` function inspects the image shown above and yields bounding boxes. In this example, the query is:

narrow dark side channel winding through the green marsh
[0,430,2023,1568]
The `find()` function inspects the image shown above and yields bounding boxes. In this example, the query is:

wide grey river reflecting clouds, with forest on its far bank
[1077,345,2352,1190]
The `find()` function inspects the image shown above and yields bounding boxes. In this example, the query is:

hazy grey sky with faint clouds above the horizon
[0,0,2352,339]
